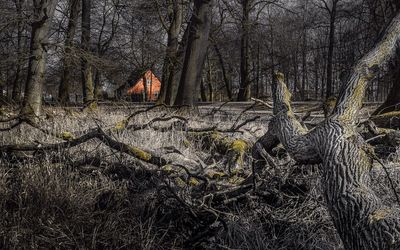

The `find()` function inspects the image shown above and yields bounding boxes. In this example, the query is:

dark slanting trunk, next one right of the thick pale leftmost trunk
[58,0,80,104]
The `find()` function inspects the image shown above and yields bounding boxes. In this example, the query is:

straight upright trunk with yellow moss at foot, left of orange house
[81,0,94,102]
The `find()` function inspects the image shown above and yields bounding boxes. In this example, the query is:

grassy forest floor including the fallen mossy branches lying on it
[0,103,400,250]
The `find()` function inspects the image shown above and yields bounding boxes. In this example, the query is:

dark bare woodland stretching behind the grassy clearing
[0,0,400,114]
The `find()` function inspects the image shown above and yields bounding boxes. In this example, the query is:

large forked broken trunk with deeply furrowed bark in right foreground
[256,10,400,249]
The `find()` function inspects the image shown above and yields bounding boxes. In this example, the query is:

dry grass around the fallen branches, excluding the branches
[0,104,400,249]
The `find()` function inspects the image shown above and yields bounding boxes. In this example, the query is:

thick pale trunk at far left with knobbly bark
[21,0,57,120]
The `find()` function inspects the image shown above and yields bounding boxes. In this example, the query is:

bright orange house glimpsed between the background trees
[128,70,161,101]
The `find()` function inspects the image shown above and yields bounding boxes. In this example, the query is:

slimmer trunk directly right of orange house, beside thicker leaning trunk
[158,0,182,105]
